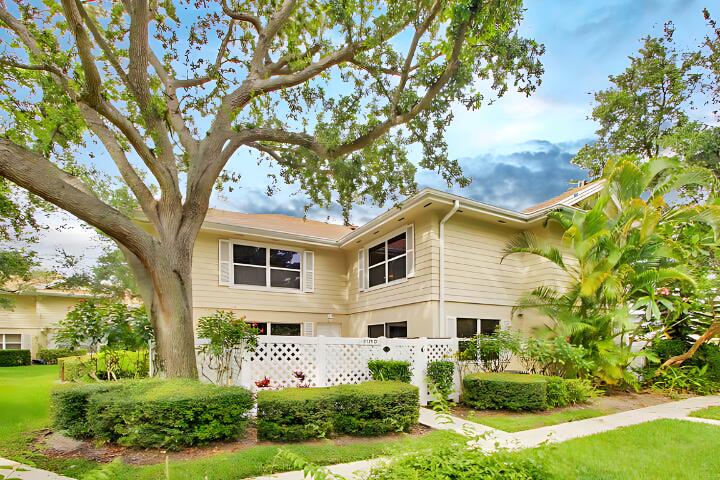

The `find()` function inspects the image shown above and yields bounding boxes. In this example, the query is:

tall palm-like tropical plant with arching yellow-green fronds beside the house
[505,156,720,383]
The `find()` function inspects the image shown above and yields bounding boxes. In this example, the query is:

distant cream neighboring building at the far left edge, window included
[0,289,92,358]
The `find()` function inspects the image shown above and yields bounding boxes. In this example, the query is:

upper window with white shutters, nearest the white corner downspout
[358,225,415,290]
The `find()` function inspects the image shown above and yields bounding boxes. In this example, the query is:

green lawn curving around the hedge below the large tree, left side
[0,365,463,480]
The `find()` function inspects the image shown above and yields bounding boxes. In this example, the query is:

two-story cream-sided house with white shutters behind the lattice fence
[184,182,602,337]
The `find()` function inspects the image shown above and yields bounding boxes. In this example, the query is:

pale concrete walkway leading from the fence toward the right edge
[256,395,720,480]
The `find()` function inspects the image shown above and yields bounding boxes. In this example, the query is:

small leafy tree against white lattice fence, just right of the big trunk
[197,310,258,385]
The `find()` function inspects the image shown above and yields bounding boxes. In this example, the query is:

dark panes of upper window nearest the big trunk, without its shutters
[232,243,302,290]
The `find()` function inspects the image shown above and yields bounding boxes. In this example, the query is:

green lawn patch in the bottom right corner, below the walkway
[520,420,720,480]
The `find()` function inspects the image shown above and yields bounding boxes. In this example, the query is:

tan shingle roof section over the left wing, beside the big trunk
[205,208,355,240]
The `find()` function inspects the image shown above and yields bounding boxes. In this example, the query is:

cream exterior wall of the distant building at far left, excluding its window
[0,295,84,358]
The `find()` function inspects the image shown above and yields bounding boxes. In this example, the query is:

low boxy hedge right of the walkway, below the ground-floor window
[463,373,548,410]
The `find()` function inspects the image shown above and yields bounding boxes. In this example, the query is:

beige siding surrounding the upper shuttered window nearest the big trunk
[192,232,347,318]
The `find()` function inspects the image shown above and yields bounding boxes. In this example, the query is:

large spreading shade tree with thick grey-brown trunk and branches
[0,0,543,376]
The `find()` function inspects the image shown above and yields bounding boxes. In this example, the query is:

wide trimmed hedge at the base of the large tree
[51,379,253,450]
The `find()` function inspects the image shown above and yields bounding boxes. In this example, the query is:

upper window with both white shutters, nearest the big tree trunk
[218,240,315,292]
